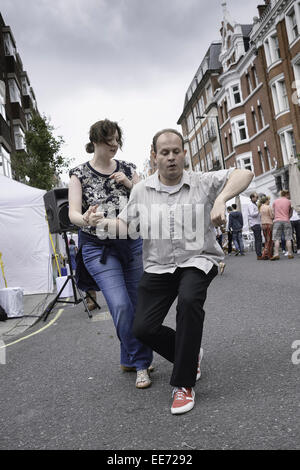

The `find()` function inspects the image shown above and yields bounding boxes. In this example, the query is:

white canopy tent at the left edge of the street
[0,175,53,294]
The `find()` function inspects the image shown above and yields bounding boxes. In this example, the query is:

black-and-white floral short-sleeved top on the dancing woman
[69,160,136,235]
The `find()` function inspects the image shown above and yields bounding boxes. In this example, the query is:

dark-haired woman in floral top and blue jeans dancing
[69,119,152,388]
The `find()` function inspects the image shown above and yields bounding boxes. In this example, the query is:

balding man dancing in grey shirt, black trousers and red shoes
[101,129,253,414]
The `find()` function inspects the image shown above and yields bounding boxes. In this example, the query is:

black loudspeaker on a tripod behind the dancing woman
[44,188,78,233]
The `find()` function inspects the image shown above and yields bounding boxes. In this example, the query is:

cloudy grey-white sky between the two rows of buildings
[0,0,263,182]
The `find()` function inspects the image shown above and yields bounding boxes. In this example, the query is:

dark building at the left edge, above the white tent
[0,14,37,177]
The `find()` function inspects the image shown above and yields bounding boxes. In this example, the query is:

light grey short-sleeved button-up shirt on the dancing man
[119,168,234,274]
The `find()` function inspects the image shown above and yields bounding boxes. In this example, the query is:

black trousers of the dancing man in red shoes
[133,266,218,387]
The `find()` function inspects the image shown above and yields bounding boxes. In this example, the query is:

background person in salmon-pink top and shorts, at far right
[270,189,294,261]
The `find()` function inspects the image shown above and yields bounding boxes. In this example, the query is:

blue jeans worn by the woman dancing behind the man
[82,239,153,370]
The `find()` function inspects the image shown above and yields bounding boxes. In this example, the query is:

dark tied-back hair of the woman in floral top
[85,119,123,153]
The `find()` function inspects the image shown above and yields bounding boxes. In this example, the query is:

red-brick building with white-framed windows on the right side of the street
[178,0,300,197]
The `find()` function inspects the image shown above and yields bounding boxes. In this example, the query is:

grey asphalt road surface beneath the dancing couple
[0,252,300,451]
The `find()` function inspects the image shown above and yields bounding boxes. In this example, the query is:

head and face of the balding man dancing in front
[154,132,186,186]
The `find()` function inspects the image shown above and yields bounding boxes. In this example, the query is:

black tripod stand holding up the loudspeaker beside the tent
[42,232,101,321]
